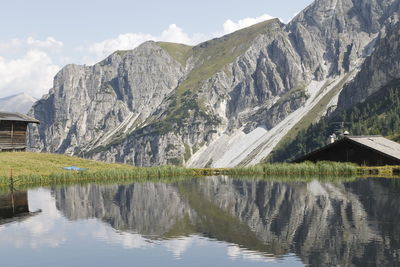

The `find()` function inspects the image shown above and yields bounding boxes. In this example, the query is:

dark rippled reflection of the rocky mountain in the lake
[54,177,400,266]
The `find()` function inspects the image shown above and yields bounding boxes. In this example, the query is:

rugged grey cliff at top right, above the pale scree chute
[287,0,399,77]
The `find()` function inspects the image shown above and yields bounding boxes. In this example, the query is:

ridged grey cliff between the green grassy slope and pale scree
[226,28,312,132]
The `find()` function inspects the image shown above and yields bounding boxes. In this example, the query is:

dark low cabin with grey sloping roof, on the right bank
[294,136,400,166]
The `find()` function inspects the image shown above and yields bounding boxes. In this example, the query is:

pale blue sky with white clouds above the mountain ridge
[0,0,312,98]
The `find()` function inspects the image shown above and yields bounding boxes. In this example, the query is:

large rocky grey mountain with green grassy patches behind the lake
[29,0,400,167]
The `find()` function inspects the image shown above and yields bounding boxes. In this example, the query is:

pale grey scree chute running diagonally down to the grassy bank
[187,77,343,168]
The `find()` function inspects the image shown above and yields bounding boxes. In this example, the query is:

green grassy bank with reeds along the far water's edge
[0,152,359,186]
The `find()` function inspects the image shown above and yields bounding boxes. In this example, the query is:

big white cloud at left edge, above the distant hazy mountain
[0,49,60,98]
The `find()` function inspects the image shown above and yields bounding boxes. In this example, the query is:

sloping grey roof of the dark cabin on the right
[294,135,400,162]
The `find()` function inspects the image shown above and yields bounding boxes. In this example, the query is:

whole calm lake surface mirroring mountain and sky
[0,177,400,267]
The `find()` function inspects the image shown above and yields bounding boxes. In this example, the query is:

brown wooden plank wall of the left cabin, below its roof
[0,121,27,150]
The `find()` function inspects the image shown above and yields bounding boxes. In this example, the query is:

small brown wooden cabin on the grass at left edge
[0,112,39,151]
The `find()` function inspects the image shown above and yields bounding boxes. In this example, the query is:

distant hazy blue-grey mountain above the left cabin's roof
[0,93,37,114]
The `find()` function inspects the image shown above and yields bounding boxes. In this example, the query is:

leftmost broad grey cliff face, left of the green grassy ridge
[32,42,183,156]
